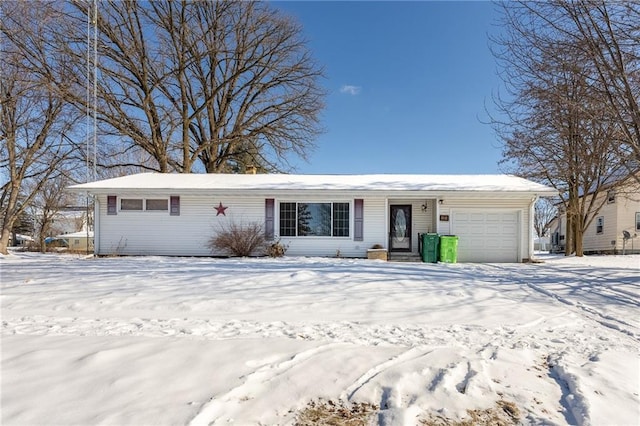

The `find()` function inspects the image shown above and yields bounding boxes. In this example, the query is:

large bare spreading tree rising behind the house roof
[72,0,324,173]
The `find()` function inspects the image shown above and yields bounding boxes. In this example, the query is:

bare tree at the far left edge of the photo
[0,2,82,254]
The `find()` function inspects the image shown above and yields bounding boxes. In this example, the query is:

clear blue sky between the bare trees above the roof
[272,1,501,174]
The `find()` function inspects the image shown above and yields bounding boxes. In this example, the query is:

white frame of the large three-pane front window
[277,200,353,239]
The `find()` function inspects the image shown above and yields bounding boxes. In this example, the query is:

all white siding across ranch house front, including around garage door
[96,191,540,261]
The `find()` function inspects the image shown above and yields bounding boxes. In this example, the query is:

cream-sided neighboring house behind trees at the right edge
[549,178,640,254]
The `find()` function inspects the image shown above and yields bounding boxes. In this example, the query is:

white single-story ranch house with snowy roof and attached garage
[70,173,557,262]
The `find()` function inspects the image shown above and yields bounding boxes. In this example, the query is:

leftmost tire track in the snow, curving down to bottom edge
[189,343,340,426]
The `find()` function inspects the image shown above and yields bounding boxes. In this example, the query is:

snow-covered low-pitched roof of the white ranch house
[69,173,557,195]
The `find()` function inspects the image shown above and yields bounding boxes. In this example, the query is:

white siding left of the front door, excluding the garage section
[97,194,387,257]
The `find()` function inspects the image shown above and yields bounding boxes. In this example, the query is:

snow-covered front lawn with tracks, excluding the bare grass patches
[0,253,640,426]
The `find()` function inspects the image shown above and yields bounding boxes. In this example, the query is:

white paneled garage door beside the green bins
[451,210,520,262]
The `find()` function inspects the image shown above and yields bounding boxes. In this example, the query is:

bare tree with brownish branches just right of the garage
[493,2,622,255]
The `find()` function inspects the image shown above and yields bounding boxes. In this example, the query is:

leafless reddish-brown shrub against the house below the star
[207,222,267,257]
